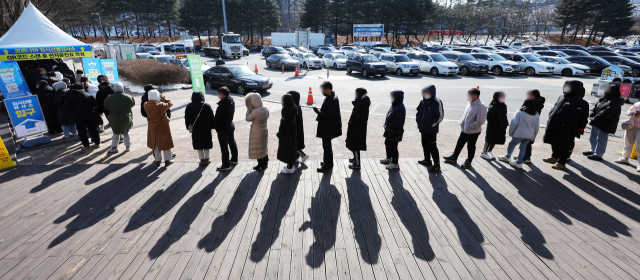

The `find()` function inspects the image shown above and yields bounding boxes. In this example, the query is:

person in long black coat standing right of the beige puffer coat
[276,94,298,174]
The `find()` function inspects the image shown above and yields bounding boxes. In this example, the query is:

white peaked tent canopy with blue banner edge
[0,2,92,61]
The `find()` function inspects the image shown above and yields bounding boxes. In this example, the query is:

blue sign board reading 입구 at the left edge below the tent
[4,95,48,137]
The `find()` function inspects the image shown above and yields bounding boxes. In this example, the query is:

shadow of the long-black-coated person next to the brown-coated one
[124,168,204,232]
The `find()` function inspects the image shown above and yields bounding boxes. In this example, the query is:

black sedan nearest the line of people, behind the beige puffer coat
[203,64,273,95]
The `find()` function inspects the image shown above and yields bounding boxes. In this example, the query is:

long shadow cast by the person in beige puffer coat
[198,172,264,252]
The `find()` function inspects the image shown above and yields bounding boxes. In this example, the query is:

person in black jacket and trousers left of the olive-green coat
[63,83,100,151]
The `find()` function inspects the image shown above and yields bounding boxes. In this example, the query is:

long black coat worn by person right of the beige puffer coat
[276,106,298,164]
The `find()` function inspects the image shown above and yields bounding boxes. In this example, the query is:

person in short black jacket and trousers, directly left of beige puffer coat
[213,87,238,171]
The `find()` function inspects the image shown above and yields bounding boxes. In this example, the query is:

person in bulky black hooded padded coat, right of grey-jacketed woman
[543,80,587,169]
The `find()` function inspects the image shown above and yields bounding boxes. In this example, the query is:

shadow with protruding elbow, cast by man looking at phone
[298,172,341,268]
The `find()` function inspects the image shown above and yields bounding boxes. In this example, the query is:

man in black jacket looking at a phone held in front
[313,81,342,172]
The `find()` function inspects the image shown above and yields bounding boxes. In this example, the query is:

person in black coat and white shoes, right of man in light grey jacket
[480,91,509,160]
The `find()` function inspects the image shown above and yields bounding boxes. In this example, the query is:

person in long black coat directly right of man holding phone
[346,88,371,169]
